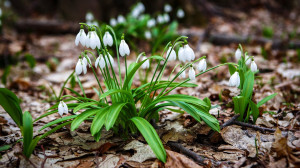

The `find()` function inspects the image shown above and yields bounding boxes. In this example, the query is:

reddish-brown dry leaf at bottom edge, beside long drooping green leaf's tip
[165,150,202,168]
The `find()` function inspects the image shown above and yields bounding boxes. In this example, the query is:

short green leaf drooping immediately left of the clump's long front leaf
[105,103,127,131]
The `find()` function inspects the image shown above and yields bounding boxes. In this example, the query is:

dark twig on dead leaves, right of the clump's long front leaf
[167,141,219,166]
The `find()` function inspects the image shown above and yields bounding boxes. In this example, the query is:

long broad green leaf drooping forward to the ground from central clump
[130,117,167,163]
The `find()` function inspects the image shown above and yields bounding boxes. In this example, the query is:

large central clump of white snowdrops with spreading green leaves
[35,23,244,162]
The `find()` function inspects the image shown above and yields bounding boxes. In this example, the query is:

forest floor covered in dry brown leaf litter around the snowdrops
[0,6,300,168]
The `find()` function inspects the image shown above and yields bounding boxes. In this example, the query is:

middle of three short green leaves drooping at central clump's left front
[91,107,110,136]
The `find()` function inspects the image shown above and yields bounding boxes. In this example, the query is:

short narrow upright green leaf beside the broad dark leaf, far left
[22,111,33,158]
